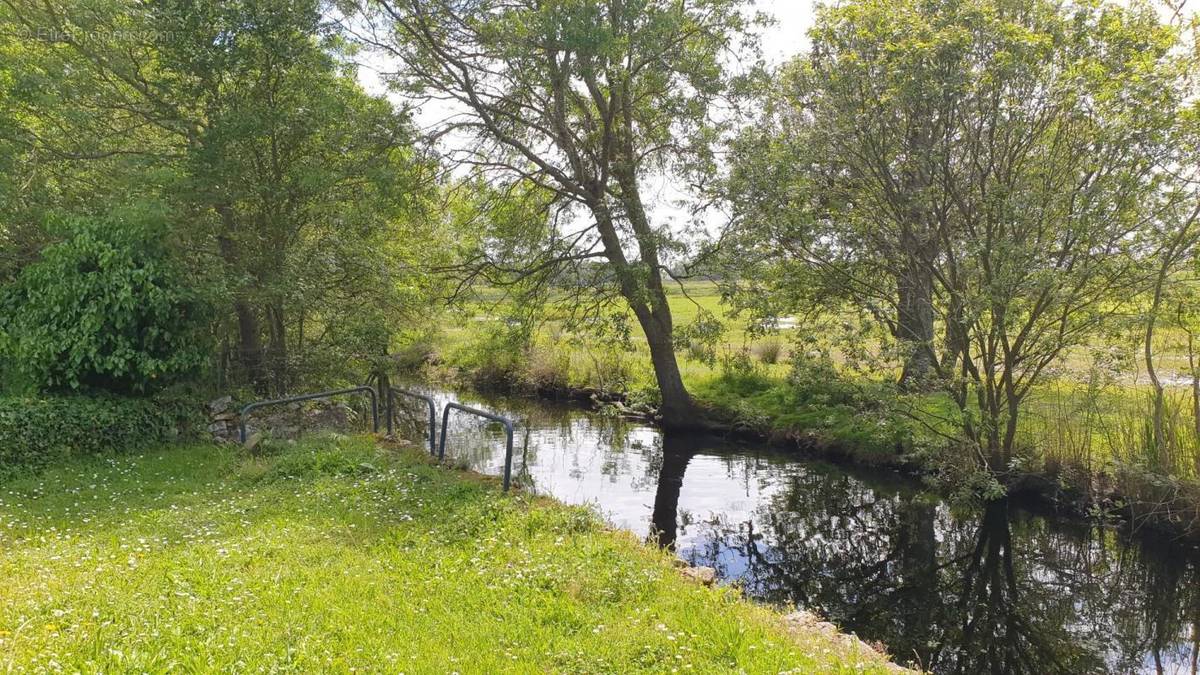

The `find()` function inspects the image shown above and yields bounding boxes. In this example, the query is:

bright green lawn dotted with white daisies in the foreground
[0,436,902,673]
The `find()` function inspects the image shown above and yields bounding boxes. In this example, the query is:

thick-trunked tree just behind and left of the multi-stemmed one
[728,2,967,386]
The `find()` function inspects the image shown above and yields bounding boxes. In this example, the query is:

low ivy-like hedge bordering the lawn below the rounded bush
[0,396,198,478]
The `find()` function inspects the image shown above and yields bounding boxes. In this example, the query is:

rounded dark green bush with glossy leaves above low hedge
[0,216,208,393]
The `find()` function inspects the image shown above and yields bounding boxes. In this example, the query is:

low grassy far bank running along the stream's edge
[421,347,1200,542]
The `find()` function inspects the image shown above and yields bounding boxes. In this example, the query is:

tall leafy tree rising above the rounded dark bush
[2,0,428,390]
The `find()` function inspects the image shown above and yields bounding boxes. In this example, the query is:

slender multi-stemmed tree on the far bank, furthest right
[938,4,1195,470]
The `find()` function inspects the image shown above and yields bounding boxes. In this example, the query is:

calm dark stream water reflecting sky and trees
[388,381,1200,673]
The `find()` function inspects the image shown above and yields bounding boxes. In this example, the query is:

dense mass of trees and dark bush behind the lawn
[0,1,436,393]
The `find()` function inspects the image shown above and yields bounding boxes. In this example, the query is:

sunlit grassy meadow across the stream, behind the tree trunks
[431,276,1200,518]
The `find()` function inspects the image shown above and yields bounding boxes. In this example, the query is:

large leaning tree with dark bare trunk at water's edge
[350,0,749,426]
